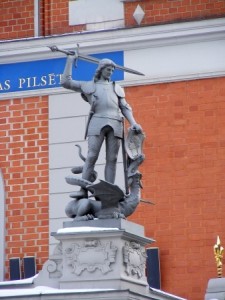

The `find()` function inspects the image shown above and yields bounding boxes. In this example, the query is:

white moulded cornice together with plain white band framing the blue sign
[0,18,225,99]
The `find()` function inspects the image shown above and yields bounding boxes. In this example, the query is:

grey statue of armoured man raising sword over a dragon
[50,46,148,221]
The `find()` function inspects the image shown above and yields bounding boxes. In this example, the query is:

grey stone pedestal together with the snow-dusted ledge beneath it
[0,219,186,300]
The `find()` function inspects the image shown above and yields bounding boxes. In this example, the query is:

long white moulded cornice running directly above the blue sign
[0,18,225,64]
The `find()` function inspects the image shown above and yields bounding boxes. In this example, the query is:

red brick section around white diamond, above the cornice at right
[124,0,225,27]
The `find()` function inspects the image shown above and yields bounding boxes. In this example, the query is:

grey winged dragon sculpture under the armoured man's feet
[65,145,147,221]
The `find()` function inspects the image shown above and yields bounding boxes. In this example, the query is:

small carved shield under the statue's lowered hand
[125,128,145,160]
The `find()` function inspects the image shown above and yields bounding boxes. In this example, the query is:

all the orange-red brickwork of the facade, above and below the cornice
[0,0,225,300]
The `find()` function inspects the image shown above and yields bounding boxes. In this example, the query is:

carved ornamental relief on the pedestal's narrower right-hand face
[123,242,147,278]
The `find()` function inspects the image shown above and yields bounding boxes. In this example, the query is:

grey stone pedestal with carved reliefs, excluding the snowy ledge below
[35,219,153,293]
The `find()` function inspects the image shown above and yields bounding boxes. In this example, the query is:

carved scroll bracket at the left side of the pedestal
[43,243,63,278]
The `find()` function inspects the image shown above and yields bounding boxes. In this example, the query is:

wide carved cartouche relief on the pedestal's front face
[65,240,117,275]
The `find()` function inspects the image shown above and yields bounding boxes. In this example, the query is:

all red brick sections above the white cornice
[0,0,225,40]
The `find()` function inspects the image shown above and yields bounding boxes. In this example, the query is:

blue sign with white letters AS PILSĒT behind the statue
[0,51,124,94]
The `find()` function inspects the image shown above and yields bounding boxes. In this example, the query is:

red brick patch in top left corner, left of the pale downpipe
[0,0,34,40]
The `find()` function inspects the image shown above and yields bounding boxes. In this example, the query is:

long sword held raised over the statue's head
[48,46,144,76]
